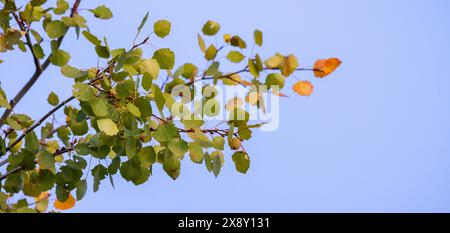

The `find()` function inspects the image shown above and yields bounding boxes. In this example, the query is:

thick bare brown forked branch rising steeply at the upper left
[0,0,81,127]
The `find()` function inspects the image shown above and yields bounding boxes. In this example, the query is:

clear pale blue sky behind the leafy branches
[0,0,450,212]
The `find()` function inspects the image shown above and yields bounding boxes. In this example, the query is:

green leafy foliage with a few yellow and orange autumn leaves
[0,0,341,212]
